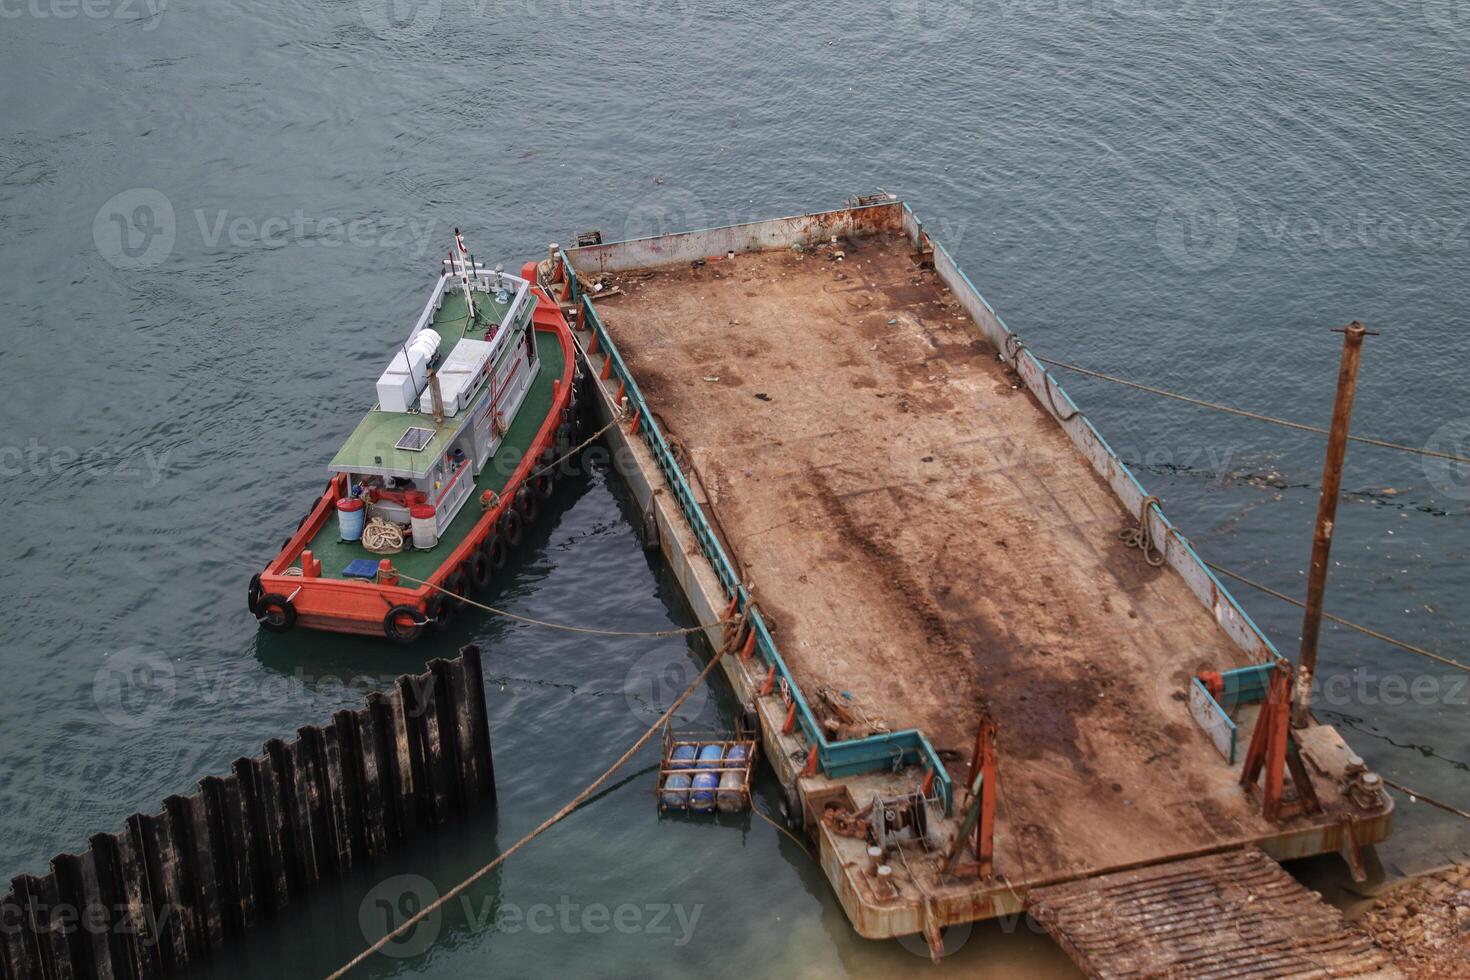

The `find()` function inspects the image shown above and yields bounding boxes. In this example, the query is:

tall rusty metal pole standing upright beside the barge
[1295,320,1377,727]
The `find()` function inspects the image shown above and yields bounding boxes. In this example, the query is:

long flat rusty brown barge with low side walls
[545,203,1391,963]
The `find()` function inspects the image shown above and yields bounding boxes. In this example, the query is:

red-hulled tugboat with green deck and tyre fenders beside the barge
[248,228,581,644]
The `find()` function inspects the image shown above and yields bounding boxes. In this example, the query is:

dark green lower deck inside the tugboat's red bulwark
[307,327,566,579]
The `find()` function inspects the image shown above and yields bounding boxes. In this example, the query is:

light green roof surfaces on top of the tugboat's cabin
[329,292,523,473]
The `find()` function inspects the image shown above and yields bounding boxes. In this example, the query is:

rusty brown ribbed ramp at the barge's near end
[1030,848,1402,980]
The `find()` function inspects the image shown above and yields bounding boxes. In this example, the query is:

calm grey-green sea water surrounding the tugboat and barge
[0,0,1470,977]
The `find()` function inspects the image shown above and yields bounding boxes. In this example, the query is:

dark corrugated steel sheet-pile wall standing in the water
[0,646,495,980]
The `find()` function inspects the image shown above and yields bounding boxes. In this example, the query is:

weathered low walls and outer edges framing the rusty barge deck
[560,203,1392,939]
